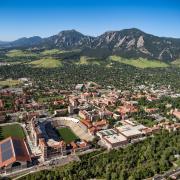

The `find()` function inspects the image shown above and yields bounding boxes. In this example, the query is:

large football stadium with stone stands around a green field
[30,117,93,160]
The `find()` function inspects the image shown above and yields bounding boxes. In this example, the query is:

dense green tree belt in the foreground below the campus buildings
[22,131,180,180]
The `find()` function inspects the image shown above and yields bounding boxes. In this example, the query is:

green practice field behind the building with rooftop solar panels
[0,124,25,140]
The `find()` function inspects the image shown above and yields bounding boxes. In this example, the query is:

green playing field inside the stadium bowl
[57,127,79,143]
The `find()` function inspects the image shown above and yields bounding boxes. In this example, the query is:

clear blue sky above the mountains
[0,0,180,41]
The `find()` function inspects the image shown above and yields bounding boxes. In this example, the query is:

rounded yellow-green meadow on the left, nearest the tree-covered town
[29,57,62,68]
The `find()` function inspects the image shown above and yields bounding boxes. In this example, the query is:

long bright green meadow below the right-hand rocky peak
[110,56,169,68]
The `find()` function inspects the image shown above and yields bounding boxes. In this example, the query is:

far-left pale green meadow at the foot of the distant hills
[6,50,37,58]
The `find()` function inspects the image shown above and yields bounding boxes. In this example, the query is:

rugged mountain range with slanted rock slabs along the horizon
[0,28,180,61]
